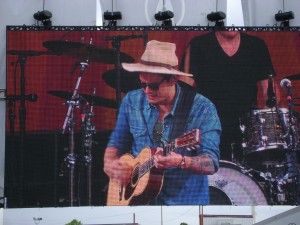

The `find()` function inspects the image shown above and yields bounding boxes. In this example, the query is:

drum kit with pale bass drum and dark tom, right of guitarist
[209,74,300,205]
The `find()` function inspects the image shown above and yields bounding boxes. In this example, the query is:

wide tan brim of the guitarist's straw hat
[122,63,193,77]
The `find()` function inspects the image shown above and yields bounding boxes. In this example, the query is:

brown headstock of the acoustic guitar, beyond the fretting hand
[174,129,201,148]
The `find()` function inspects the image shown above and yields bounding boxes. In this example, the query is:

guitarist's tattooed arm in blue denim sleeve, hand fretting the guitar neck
[154,98,221,175]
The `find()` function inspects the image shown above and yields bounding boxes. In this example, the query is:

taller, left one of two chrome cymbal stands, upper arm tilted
[62,57,88,206]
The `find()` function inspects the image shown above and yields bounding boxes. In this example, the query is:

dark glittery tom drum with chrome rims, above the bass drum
[240,108,295,163]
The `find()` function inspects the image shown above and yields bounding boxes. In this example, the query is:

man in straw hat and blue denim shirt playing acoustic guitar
[104,41,221,205]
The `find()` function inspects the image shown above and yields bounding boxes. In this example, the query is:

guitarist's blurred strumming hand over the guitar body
[104,147,132,185]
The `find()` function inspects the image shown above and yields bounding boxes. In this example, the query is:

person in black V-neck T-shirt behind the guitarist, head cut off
[182,31,279,161]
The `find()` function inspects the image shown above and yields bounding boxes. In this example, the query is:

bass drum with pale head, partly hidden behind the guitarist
[208,160,268,205]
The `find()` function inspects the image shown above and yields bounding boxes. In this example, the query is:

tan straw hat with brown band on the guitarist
[122,40,193,77]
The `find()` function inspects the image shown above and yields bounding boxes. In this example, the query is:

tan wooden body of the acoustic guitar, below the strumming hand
[107,148,164,206]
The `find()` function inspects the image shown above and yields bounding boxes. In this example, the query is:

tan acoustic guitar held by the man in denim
[107,129,201,206]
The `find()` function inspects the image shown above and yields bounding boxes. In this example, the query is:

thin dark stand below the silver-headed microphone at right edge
[286,85,300,205]
